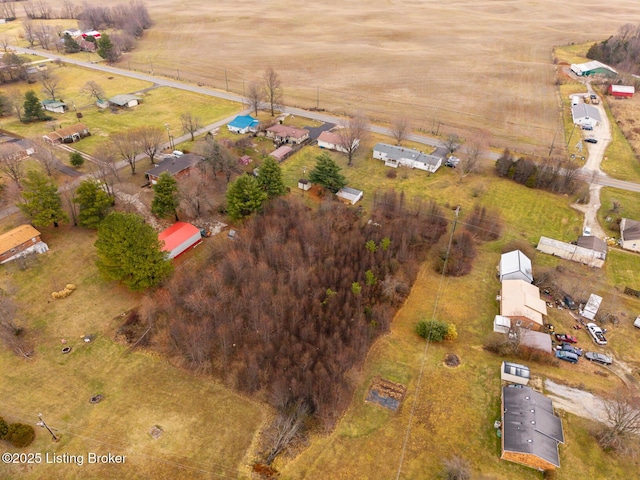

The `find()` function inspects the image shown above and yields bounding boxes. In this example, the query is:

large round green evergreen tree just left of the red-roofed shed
[95,212,173,291]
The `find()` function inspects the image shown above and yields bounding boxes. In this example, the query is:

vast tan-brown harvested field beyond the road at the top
[43,0,640,151]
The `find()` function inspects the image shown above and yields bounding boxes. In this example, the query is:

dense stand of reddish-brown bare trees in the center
[147,194,447,432]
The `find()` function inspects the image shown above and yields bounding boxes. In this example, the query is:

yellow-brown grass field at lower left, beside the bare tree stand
[0,227,265,479]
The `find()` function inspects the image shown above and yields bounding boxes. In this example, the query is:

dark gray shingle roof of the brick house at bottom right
[502,386,564,467]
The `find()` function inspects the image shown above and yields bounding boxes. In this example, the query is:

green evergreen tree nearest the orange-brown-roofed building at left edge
[18,170,69,227]
